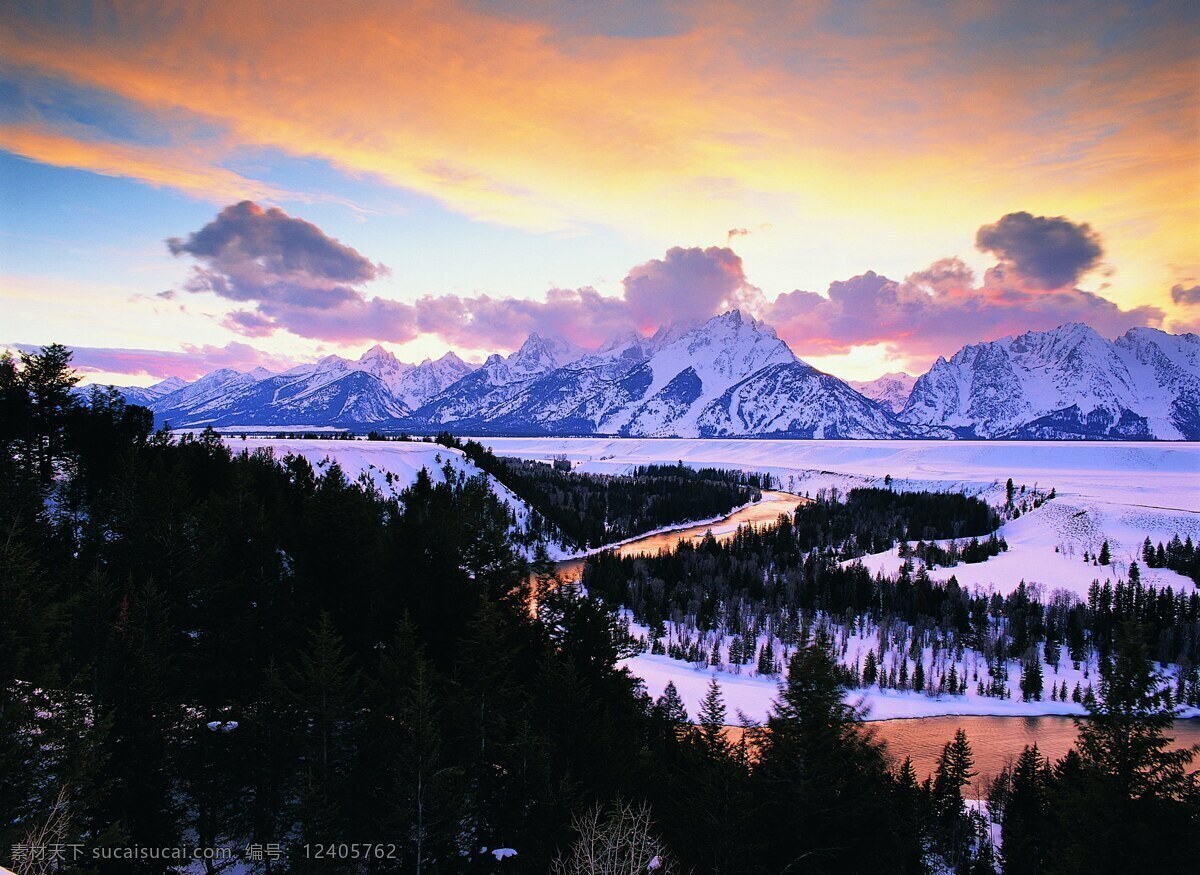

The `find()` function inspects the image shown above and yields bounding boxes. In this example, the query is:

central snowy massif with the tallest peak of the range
[416,310,854,437]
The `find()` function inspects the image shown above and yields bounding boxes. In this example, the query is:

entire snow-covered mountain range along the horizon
[103,310,1200,441]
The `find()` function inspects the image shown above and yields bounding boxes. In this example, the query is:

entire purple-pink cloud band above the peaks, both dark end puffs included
[168,202,1161,364]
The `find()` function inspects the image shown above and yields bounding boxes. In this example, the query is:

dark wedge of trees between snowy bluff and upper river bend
[437,432,770,547]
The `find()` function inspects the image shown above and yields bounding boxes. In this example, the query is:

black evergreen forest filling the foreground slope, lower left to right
[0,347,1196,875]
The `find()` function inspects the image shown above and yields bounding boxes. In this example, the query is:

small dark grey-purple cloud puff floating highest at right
[976,212,1104,289]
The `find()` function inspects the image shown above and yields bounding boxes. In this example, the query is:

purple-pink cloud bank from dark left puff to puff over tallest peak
[167,200,762,349]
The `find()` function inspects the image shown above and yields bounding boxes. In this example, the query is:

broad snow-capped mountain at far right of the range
[899,323,1200,441]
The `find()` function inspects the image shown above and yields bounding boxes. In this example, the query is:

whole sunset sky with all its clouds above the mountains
[0,0,1200,384]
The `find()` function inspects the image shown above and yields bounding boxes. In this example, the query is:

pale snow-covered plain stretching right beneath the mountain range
[485,438,1200,595]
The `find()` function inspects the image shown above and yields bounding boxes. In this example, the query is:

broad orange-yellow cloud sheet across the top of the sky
[0,0,1200,319]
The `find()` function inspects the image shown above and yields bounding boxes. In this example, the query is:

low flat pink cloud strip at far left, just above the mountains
[13,341,296,380]
